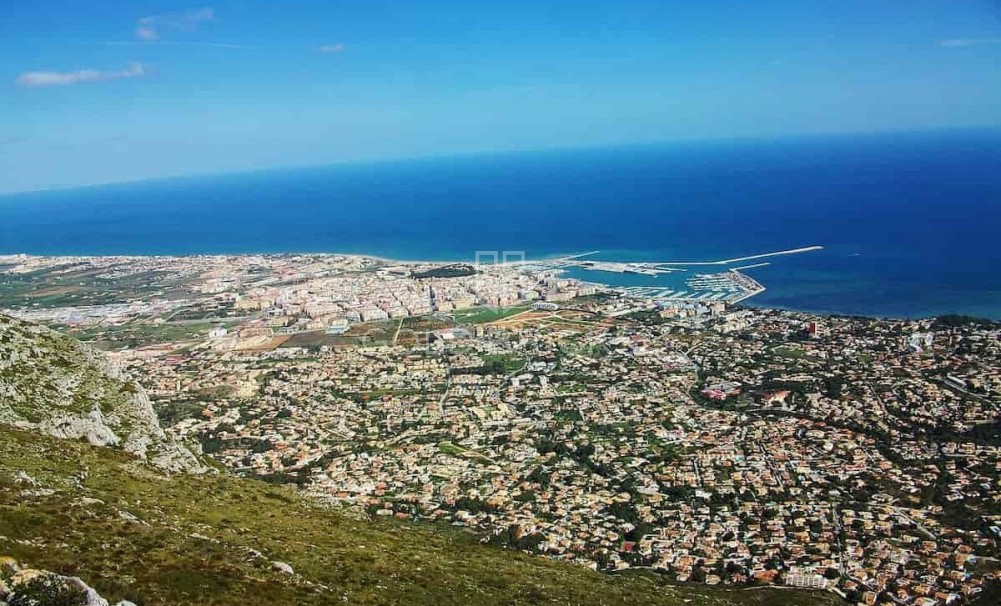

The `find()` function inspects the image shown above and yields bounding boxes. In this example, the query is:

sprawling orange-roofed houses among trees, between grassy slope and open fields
[119,304,999,605]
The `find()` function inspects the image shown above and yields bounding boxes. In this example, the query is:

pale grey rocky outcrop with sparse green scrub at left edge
[0,316,204,473]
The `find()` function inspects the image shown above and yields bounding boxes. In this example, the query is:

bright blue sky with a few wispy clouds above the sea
[0,0,1001,192]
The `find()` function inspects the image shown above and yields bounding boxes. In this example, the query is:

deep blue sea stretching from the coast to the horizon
[0,129,1001,319]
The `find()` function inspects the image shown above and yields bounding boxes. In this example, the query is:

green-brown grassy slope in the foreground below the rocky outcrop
[0,426,838,606]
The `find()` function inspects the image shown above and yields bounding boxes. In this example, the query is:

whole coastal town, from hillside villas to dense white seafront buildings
[0,254,1001,606]
